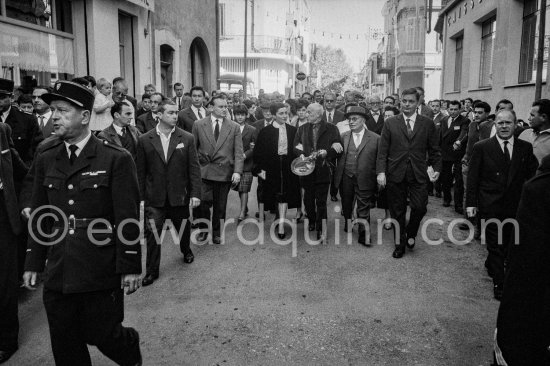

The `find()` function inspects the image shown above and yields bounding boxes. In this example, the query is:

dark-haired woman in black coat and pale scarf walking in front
[254,103,301,238]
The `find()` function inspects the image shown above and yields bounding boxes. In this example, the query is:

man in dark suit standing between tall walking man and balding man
[439,100,470,214]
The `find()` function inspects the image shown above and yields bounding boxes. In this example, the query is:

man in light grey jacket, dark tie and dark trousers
[193,95,244,244]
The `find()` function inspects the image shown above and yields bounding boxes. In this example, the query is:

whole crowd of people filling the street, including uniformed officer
[0,76,550,365]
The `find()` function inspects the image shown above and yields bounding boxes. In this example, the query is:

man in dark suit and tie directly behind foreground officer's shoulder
[97,101,141,161]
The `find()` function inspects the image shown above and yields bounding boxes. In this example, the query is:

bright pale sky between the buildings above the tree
[307,0,385,72]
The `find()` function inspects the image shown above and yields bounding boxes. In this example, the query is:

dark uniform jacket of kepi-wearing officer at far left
[4,107,43,164]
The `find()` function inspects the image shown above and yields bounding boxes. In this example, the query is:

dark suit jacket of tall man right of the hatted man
[376,114,441,183]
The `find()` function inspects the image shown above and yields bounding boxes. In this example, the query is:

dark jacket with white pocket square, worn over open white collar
[137,127,202,207]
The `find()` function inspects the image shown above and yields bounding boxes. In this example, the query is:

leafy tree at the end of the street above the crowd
[311,46,353,93]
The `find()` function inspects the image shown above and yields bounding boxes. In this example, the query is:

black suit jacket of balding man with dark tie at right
[466,136,538,217]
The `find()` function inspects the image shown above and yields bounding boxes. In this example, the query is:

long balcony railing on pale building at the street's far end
[220,35,303,58]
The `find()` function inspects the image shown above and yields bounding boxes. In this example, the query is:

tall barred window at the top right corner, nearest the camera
[518,0,550,83]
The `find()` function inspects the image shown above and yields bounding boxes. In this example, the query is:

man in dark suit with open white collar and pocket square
[137,101,201,286]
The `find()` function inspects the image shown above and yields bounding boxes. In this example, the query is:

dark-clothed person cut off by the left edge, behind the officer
[0,123,28,363]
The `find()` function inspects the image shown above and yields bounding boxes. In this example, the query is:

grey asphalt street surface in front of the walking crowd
[7,181,498,366]
